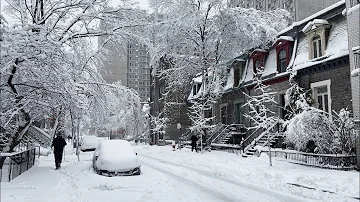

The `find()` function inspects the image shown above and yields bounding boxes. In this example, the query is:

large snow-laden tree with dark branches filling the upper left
[0,0,149,152]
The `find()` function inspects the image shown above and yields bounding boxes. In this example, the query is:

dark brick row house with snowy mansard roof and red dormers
[189,1,359,153]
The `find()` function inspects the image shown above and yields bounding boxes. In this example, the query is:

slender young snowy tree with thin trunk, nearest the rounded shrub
[243,67,280,166]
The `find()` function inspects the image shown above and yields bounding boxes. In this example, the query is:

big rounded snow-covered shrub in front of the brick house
[286,107,356,154]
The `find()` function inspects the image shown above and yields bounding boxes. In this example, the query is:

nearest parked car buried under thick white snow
[93,140,141,176]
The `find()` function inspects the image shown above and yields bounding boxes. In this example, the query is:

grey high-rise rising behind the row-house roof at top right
[229,0,339,22]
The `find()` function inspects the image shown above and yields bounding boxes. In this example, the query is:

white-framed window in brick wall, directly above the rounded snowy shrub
[311,80,331,118]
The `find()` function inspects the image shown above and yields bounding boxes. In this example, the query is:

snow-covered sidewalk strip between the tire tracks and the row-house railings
[135,145,360,202]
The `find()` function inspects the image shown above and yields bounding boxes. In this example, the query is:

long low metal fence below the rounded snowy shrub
[262,150,356,170]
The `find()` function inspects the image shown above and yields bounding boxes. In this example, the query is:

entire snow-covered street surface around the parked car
[1,145,359,202]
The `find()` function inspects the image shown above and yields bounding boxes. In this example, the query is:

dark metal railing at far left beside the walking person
[0,147,36,182]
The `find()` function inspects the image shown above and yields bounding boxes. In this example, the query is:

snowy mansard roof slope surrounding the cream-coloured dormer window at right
[293,21,349,70]
